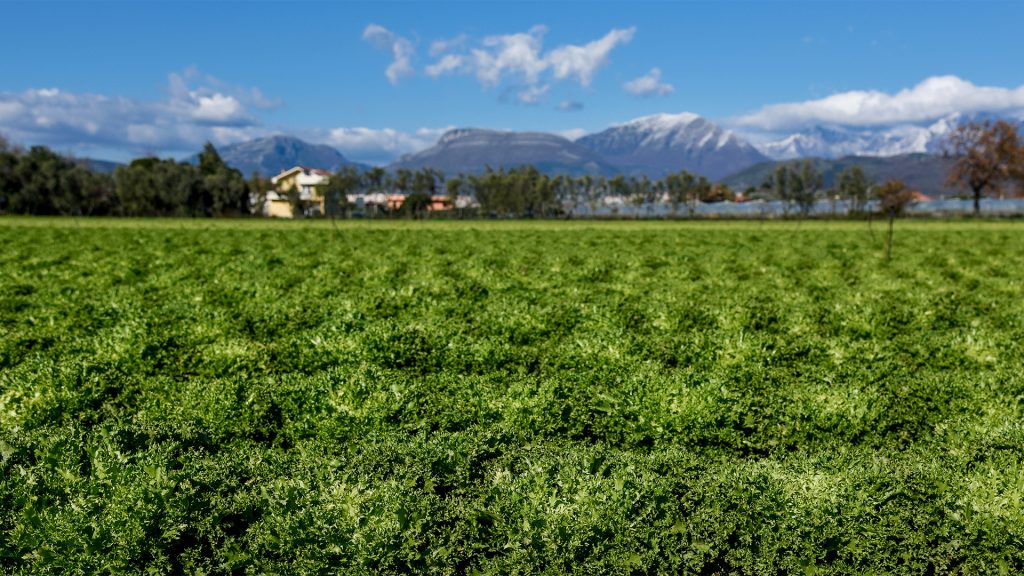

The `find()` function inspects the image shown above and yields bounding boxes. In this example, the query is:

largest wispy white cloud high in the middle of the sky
[425,26,636,104]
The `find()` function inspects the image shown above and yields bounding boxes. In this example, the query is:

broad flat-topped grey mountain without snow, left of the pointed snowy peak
[388,129,616,175]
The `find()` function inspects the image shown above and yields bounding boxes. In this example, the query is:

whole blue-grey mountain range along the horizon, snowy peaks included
[174,113,1024,195]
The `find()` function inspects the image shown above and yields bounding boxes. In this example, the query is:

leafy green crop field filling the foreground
[0,218,1024,574]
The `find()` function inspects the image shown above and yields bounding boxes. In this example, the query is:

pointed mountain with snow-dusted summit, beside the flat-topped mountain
[577,113,767,178]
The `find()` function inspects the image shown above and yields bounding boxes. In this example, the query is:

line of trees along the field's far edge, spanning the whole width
[0,121,1024,218]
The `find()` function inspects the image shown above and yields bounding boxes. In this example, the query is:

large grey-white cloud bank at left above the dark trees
[0,70,270,154]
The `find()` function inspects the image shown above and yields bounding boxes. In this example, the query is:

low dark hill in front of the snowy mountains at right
[722,154,963,197]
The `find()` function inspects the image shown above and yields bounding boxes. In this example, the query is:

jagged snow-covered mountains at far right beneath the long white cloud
[756,114,978,160]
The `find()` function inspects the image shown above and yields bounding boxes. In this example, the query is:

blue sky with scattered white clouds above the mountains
[0,1,1024,162]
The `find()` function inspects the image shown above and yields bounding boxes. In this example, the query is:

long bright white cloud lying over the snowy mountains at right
[735,76,1024,130]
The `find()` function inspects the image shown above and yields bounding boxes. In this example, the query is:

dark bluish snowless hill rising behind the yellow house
[189,135,366,177]
